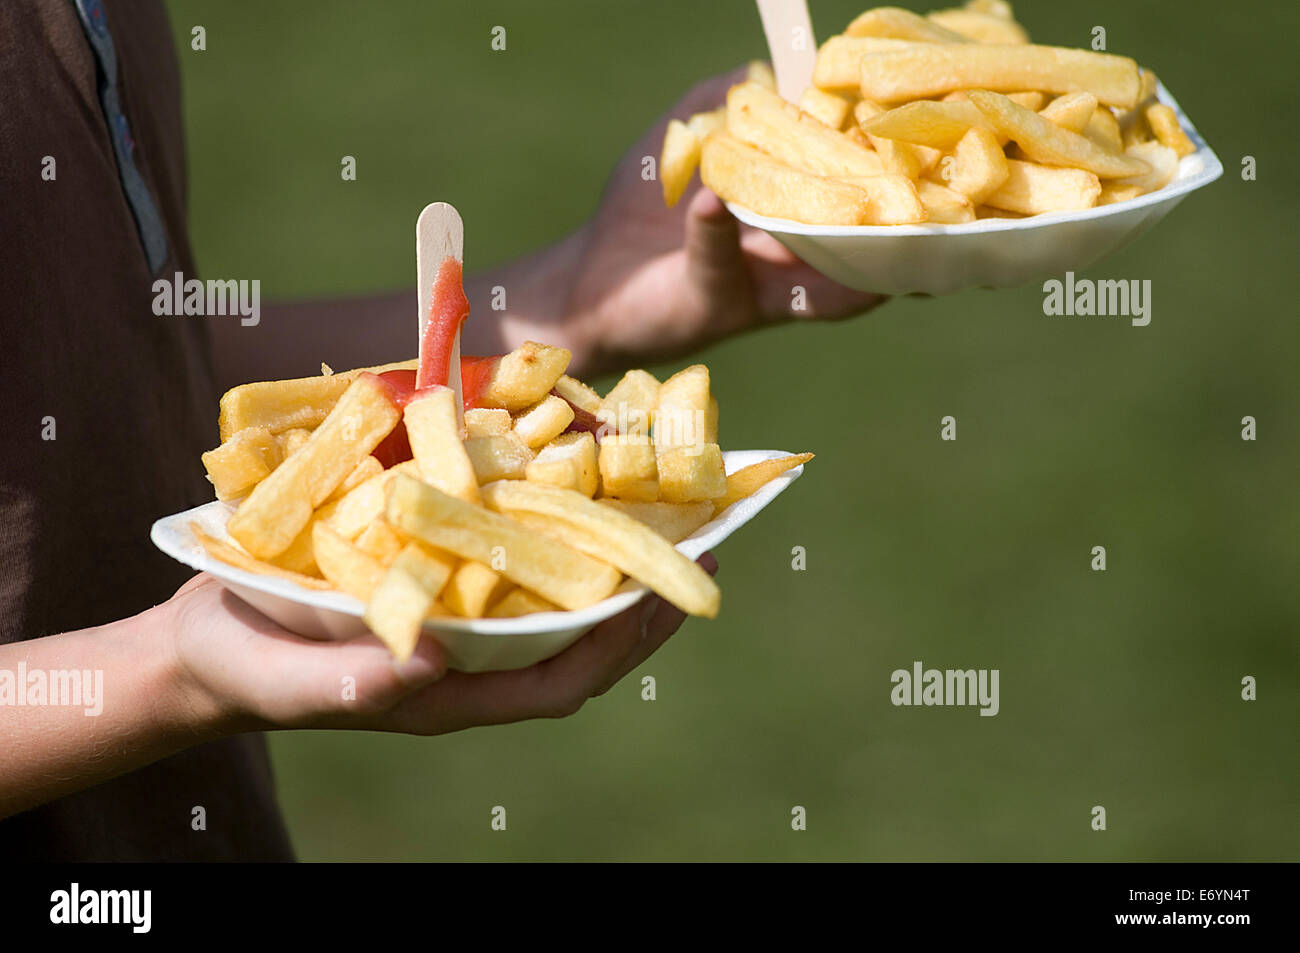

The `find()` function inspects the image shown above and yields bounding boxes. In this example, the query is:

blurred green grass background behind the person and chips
[170,0,1300,861]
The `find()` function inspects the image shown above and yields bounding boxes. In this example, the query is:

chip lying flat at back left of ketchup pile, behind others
[217,360,416,442]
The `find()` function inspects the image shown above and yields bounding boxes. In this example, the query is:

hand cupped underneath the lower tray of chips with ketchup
[165,554,718,735]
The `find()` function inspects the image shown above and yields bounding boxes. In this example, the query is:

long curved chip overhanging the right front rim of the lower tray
[484,481,722,618]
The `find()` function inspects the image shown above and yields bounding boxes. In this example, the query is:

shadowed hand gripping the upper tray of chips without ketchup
[569,70,885,369]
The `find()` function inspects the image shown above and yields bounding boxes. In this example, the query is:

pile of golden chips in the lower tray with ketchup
[192,342,811,658]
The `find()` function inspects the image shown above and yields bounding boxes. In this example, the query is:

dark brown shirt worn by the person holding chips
[0,0,293,861]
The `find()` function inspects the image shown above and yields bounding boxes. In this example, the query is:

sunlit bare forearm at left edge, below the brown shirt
[0,603,221,818]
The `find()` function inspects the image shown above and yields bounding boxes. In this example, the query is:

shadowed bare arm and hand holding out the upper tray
[213,73,883,389]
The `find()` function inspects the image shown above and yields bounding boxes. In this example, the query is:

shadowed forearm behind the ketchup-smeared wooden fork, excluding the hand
[212,229,594,390]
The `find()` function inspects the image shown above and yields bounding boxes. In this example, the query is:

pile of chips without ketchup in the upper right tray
[659,0,1196,225]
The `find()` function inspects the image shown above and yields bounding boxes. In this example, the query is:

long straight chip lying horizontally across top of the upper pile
[861,43,1140,109]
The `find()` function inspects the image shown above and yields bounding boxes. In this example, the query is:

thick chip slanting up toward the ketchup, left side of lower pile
[226,376,402,559]
